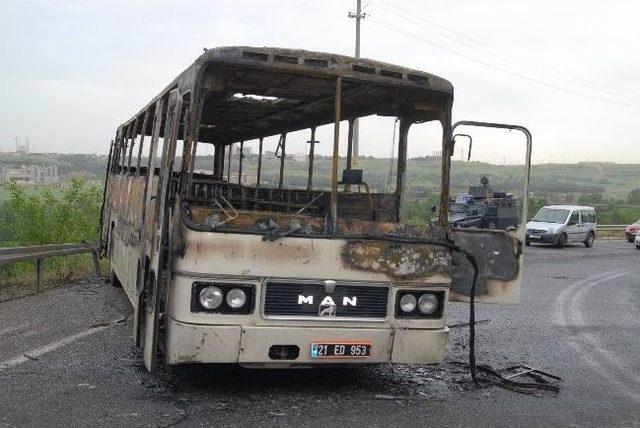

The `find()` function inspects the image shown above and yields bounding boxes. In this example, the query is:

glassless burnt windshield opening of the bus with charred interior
[162,51,453,238]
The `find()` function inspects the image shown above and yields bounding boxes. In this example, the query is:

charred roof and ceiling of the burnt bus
[123,46,453,144]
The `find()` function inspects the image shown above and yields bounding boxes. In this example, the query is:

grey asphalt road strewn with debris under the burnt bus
[0,241,640,427]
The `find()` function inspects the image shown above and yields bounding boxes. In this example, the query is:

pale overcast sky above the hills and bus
[0,0,640,163]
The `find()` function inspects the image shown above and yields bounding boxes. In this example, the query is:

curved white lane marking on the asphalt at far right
[555,271,640,402]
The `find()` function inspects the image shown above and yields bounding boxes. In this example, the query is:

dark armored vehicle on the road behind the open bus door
[449,177,518,230]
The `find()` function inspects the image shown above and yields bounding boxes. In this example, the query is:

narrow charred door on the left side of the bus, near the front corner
[137,90,182,371]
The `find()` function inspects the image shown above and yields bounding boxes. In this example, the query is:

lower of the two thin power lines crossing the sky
[369,14,640,109]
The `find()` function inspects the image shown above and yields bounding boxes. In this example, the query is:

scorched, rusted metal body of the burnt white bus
[103,47,522,368]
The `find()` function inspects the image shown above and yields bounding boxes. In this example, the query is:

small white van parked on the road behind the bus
[525,205,598,248]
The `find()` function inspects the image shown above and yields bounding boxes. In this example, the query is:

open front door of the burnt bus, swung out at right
[448,121,531,303]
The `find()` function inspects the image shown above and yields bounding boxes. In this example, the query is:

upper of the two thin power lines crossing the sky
[371,0,640,99]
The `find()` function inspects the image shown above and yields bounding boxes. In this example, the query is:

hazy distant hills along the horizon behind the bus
[0,153,640,202]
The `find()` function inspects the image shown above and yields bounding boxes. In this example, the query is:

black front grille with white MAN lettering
[264,281,389,319]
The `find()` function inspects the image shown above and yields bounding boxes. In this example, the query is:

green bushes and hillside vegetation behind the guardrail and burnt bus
[0,154,640,286]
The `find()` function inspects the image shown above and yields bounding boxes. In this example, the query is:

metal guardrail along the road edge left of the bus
[0,244,100,293]
